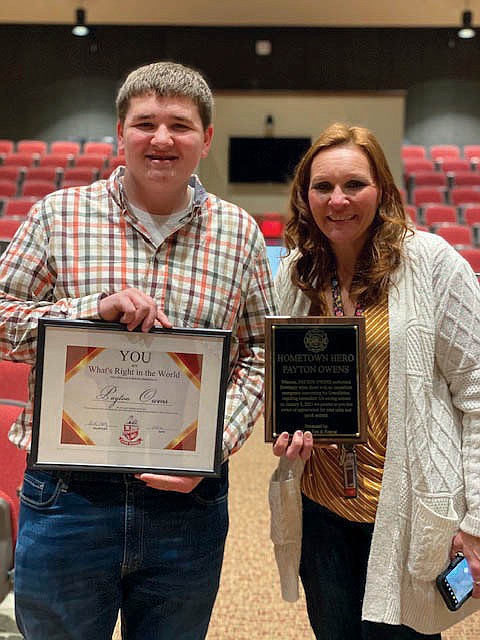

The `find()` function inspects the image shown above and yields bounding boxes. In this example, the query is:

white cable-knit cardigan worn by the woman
[275,232,480,634]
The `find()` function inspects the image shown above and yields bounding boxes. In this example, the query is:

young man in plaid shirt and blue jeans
[0,62,274,640]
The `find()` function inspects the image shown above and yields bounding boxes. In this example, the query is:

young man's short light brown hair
[116,61,213,129]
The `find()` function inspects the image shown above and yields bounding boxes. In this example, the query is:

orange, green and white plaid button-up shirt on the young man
[0,167,275,458]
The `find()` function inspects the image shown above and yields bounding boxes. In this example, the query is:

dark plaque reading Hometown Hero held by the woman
[265,316,367,444]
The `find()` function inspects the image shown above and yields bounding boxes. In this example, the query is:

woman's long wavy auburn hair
[285,123,410,315]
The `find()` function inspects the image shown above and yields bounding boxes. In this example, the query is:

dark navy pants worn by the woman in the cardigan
[300,496,441,640]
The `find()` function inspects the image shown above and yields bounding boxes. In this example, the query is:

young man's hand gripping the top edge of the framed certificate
[98,288,172,333]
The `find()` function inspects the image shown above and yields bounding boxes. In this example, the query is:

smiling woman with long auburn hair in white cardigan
[274,124,480,640]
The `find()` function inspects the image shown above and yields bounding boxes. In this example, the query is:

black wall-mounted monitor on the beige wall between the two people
[228,137,311,183]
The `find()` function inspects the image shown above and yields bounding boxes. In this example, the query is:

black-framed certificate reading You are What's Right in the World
[29,318,231,477]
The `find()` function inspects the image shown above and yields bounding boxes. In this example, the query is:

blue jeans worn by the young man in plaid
[15,464,228,640]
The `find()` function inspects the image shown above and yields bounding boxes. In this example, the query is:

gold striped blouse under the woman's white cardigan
[302,301,390,522]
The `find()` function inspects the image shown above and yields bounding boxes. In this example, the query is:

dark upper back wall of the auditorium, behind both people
[0,25,480,198]
